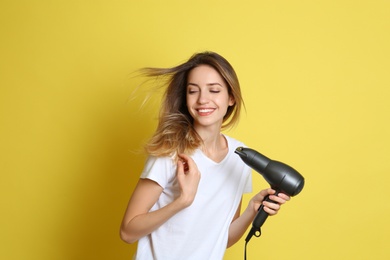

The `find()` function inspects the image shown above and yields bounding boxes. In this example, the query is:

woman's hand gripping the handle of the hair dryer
[250,188,290,215]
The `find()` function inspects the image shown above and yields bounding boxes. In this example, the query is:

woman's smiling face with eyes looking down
[186,65,234,129]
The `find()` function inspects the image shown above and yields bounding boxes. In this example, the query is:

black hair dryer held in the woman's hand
[235,147,305,242]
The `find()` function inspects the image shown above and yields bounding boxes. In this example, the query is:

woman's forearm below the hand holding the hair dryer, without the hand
[227,207,256,247]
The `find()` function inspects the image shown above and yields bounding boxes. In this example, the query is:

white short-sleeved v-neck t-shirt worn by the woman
[135,136,252,260]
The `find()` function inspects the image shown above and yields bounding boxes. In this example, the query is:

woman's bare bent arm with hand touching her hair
[120,155,200,243]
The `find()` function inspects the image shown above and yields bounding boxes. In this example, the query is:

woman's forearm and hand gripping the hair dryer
[227,189,290,247]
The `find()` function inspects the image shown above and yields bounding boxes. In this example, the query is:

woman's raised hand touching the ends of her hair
[176,154,201,207]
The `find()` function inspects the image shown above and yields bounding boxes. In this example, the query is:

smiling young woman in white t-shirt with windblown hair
[120,52,290,260]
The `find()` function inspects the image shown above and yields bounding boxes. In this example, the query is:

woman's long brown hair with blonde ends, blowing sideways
[141,51,244,157]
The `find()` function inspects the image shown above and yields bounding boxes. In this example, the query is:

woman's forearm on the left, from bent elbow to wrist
[120,199,186,243]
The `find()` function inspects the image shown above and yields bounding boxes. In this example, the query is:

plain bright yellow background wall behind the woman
[0,0,390,260]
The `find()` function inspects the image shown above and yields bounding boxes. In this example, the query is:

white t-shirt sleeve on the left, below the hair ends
[140,156,176,188]
